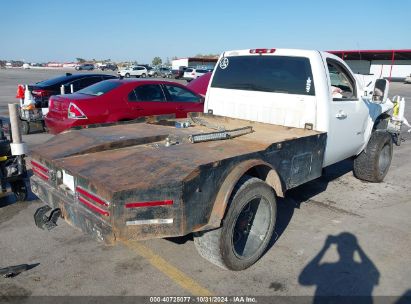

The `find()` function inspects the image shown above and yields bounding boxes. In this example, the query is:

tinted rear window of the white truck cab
[211,56,315,95]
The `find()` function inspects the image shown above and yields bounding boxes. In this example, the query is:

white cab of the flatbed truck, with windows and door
[204,49,393,167]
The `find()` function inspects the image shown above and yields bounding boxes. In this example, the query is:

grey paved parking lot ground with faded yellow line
[0,69,411,303]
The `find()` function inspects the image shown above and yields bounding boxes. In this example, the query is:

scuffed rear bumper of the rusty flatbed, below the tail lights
[30,176,116,244]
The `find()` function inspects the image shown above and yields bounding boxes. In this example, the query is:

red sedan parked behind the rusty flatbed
[45,79,204,134]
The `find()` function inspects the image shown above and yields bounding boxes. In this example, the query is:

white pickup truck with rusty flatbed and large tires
[31,49,393,270]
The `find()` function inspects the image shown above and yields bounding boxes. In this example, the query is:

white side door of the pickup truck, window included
[324,57,369,166]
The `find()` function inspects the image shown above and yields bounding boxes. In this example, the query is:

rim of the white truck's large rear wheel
[232,197,271,259]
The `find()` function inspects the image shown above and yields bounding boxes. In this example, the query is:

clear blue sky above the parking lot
[0,0,411,63]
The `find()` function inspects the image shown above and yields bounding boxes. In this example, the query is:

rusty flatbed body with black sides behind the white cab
[31,114,326,241]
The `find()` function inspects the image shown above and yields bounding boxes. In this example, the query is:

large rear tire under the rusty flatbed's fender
[194,176,277,271]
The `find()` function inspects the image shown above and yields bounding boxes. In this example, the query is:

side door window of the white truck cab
[327,59,357,101]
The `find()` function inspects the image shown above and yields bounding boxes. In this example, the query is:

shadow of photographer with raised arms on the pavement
[298,232,380,303]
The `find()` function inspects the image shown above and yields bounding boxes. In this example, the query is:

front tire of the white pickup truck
[354,131,393,183]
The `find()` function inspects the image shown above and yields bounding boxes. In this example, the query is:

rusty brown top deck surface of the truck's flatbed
[32,115,320,195]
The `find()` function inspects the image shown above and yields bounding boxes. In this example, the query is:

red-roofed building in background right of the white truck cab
[328,49,411,81]
